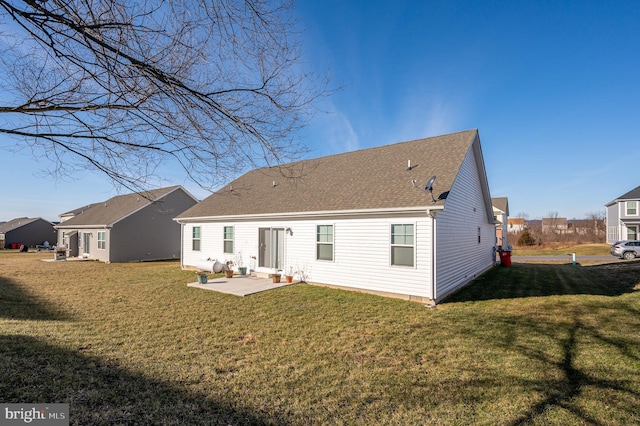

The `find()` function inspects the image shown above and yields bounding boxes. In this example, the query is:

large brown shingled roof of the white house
[178,129,478,219]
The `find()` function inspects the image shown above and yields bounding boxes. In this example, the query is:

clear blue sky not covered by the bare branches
[0,0,640,221]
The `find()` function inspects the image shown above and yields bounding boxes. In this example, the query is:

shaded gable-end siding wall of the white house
[436,150,495,301]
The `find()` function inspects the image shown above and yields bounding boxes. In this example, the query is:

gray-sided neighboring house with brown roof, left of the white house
[56,186,198,262]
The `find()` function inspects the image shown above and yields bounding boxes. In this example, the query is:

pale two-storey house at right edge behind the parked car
[605,186,640,244]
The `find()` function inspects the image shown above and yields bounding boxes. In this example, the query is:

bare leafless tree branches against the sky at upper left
[0,0,327,190]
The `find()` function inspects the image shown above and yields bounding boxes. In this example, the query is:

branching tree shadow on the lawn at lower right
[491,303,640,426]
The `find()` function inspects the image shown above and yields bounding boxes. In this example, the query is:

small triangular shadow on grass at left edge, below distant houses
[0,276,71,321]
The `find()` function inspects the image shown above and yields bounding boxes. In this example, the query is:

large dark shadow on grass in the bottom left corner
[0,336,287,425]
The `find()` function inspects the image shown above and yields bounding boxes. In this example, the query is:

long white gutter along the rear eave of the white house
[173,206,444,224]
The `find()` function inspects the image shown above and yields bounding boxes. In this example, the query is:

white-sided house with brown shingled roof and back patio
[176,130,495,302]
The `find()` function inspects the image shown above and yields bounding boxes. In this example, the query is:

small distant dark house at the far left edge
[0,217,56,248]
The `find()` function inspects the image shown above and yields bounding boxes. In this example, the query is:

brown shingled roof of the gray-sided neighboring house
[56,186,182,228]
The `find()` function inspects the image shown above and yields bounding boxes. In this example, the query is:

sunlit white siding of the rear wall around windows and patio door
[183,213,438,297]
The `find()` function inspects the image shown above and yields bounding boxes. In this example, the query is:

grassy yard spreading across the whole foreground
[0,252,640,425]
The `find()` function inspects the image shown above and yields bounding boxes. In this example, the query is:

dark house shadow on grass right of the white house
[443,261,640,303]
